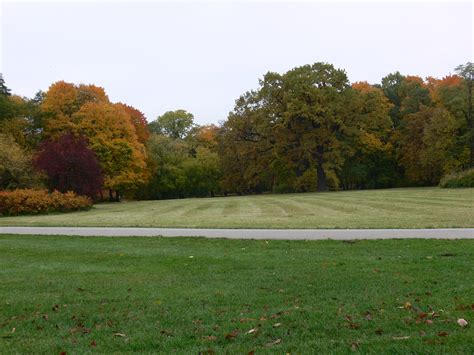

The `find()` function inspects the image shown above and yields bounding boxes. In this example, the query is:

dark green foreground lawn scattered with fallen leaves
[0,235,474,354]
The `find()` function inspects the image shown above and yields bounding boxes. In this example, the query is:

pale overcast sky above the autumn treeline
[0,0,474,124]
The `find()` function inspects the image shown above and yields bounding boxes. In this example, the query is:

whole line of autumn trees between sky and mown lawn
[0,63,474,200]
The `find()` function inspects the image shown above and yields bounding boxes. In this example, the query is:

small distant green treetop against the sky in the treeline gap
[148,110,194,139]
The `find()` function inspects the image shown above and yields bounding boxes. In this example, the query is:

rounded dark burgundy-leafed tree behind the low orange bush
[34,133,103,197]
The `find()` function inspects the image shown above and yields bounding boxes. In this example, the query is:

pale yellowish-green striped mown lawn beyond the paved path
[0,188,474,228]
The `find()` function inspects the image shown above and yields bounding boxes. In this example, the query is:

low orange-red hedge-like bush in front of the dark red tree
[0,189,92,216]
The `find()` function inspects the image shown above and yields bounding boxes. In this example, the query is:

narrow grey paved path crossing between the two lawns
[0,227,474,240]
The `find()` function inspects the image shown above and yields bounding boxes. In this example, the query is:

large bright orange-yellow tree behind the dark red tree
[41,81,147,200]
